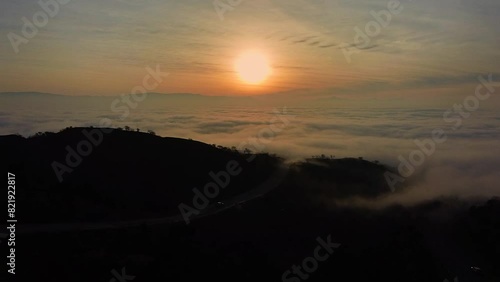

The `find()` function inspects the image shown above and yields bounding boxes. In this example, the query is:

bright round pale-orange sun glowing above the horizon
[234,51,271,84]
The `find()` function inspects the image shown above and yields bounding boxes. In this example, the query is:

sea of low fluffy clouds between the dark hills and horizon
[0,93,500,204]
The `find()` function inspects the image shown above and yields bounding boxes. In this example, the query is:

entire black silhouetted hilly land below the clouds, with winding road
[0,129,500,282]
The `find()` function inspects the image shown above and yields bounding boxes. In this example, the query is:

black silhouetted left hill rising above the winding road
[0,128,279,223]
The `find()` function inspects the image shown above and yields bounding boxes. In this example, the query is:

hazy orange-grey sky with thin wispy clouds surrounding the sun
[0,0,500,95]
